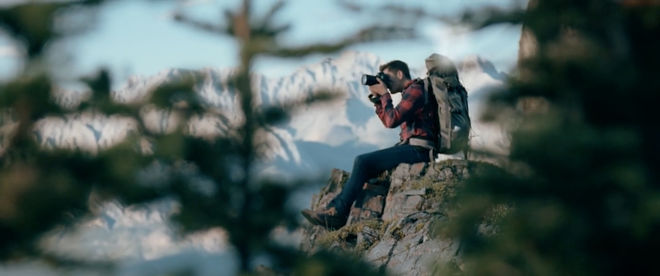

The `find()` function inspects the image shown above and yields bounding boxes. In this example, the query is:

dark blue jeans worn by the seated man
[328,144,430,215]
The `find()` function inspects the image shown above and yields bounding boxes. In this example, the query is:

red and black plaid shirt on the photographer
[374,80,438,142]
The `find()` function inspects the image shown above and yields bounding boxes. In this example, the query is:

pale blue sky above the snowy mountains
[0,0,525,88]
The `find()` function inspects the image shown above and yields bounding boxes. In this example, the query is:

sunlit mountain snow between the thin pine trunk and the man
[261,52,396,149]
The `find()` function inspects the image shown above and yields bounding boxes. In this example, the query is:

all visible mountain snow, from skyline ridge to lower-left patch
[7,52,506,274]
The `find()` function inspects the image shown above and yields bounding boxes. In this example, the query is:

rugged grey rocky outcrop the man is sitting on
[301,160,498,275]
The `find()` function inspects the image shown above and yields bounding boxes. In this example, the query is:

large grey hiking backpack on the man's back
[423,53,472,156]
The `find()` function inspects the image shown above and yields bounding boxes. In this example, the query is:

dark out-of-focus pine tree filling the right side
[447,0,660,275]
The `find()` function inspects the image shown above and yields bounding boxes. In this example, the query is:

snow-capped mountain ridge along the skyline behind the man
[39,52,505,175]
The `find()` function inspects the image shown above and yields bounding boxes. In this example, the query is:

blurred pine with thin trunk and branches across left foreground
[0,0,412,275]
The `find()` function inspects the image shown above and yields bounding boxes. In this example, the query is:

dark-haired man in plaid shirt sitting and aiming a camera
[302,60,438,229]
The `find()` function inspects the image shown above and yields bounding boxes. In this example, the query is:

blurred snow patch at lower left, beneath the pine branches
[42,200,227,261]
